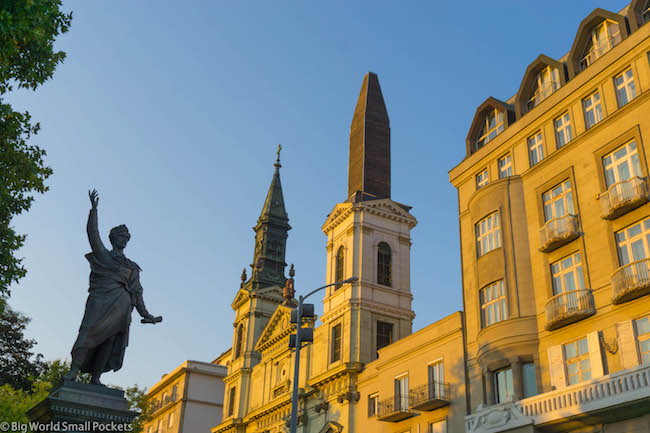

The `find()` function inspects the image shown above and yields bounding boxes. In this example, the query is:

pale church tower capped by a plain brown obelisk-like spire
[321,73,417,369]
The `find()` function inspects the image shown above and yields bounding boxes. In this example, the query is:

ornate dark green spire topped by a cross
[251,146,291,290]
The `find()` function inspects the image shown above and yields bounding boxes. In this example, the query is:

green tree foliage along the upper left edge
[0,0,72,296]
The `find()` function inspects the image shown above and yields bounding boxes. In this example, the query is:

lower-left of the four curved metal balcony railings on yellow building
[545,289,596,331]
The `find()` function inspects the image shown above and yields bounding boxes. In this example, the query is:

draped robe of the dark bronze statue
[72,246,144,373]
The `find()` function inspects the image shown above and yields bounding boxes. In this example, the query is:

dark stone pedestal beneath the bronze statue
[27,382,139,432]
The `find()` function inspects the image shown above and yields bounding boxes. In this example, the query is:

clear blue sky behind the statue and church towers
[10,0,627,387]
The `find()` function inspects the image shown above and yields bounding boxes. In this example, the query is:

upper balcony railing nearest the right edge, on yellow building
[600,177,648,220]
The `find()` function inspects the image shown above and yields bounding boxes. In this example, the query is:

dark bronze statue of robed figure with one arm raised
[64,190,162,385]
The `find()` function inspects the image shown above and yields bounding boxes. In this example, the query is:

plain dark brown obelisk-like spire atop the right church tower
[348,72,390,201]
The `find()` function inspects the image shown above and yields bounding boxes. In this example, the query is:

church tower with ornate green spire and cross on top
[223,146,291,424]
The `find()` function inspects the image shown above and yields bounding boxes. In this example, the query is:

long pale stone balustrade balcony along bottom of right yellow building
[465,365,650,433]
